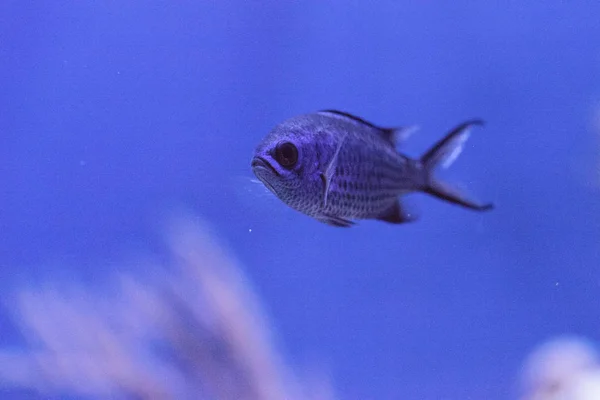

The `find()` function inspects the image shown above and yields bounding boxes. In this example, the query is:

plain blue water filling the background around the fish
[0,1,600,400]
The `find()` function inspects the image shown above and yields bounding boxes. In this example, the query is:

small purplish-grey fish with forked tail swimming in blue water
[251,110,494,227]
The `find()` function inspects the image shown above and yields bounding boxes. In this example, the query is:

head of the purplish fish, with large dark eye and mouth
[251,118,330,212]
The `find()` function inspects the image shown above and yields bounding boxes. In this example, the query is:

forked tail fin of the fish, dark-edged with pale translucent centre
[421,119,494,211]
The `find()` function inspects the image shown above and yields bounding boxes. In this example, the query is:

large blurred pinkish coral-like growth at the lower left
[0,218,332,400]
